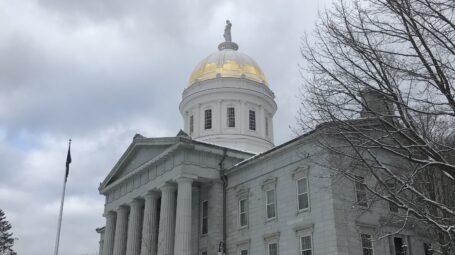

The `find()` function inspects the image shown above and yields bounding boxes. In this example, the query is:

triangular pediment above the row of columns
[100,138,178,189]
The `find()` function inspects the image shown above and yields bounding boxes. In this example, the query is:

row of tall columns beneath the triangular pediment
[103,176,197,255]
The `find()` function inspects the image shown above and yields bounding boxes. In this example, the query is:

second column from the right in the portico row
[158,183,175,255]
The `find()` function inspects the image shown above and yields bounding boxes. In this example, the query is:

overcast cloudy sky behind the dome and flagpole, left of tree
[0,0,330,255]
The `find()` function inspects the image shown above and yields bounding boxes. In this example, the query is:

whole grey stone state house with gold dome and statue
[97,22,431,255]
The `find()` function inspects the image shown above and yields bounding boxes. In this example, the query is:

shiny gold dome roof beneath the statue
[188,48,267,86]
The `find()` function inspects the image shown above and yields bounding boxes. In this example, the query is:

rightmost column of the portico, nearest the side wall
[174,177,193,255]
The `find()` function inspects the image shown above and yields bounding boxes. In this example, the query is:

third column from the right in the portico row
[141,192,160,255]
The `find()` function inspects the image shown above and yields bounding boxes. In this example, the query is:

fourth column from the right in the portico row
[126,199,143,255]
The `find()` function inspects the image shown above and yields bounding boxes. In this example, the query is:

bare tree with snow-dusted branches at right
[298,0,455,254]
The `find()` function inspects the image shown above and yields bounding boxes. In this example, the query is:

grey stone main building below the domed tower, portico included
[100,132,432,255]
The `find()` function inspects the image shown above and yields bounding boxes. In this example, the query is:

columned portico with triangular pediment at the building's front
[100,136,250,255]
